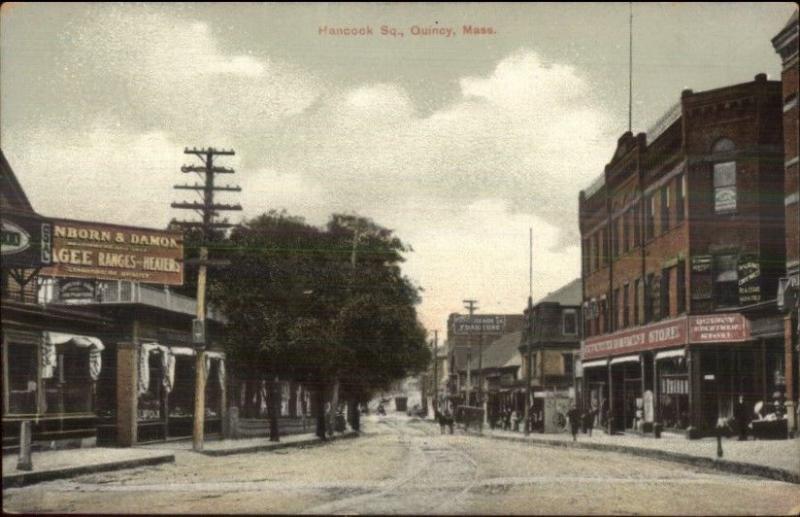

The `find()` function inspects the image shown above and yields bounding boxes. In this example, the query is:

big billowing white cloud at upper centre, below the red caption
[274,51,610,245]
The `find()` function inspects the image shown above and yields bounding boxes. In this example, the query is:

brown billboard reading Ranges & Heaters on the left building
[42,219,183,285]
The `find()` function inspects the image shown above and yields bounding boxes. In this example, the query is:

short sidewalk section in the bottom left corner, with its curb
[3,447,175,488]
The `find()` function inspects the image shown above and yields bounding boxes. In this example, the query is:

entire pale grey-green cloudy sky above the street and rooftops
[0,3,795,334]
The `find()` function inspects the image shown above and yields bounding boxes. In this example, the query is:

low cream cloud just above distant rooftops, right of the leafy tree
[386,199,580,331]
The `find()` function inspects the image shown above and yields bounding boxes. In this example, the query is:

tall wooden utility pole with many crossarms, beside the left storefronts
[172,147,242,451]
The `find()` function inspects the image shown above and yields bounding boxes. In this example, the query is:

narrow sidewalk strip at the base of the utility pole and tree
[136,431,358,456]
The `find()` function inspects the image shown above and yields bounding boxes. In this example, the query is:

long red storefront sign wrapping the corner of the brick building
[583,313,750,360]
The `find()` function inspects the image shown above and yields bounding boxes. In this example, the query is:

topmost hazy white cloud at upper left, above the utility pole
[65,4,319,141]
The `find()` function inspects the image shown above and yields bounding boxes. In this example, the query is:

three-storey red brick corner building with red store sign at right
[579,74,785,436]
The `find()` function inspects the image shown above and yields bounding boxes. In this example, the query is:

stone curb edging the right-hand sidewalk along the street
[472,433,800,484]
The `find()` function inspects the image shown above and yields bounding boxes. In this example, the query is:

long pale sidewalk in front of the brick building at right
[470,428,800,484]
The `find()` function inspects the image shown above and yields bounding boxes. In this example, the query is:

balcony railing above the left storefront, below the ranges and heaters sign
[40,281,225,322]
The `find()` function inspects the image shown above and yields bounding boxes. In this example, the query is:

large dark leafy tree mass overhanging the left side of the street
[210,211,430,436]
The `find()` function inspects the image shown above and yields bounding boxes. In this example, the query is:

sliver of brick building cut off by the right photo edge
[772,11,800,430]
